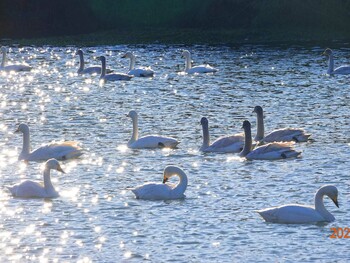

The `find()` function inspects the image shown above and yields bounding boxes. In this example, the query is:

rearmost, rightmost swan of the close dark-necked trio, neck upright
[253,106,311,143]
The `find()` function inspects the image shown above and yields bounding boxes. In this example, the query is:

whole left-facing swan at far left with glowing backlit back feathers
[15,123,83,161]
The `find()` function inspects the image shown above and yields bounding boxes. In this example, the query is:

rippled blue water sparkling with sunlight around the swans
[0,44,350,262]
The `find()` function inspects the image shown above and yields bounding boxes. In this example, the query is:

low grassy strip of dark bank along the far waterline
[0,29,350,46]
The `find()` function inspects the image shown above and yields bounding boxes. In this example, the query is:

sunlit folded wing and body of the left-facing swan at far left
[27,141,83,161]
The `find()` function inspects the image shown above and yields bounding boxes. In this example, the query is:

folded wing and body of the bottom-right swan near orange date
[257,205,325,224]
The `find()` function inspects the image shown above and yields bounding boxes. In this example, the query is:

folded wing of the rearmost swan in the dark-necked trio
[263,128,311,142]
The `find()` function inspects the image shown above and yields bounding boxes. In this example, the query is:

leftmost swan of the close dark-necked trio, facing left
[199,117,244,153]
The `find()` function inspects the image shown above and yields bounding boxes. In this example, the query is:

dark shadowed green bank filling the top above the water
[0,0,350,45]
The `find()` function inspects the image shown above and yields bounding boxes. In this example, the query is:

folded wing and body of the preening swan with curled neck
[131,183,172,200]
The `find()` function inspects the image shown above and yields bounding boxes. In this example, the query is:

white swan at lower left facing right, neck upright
[7,159,64,198]
